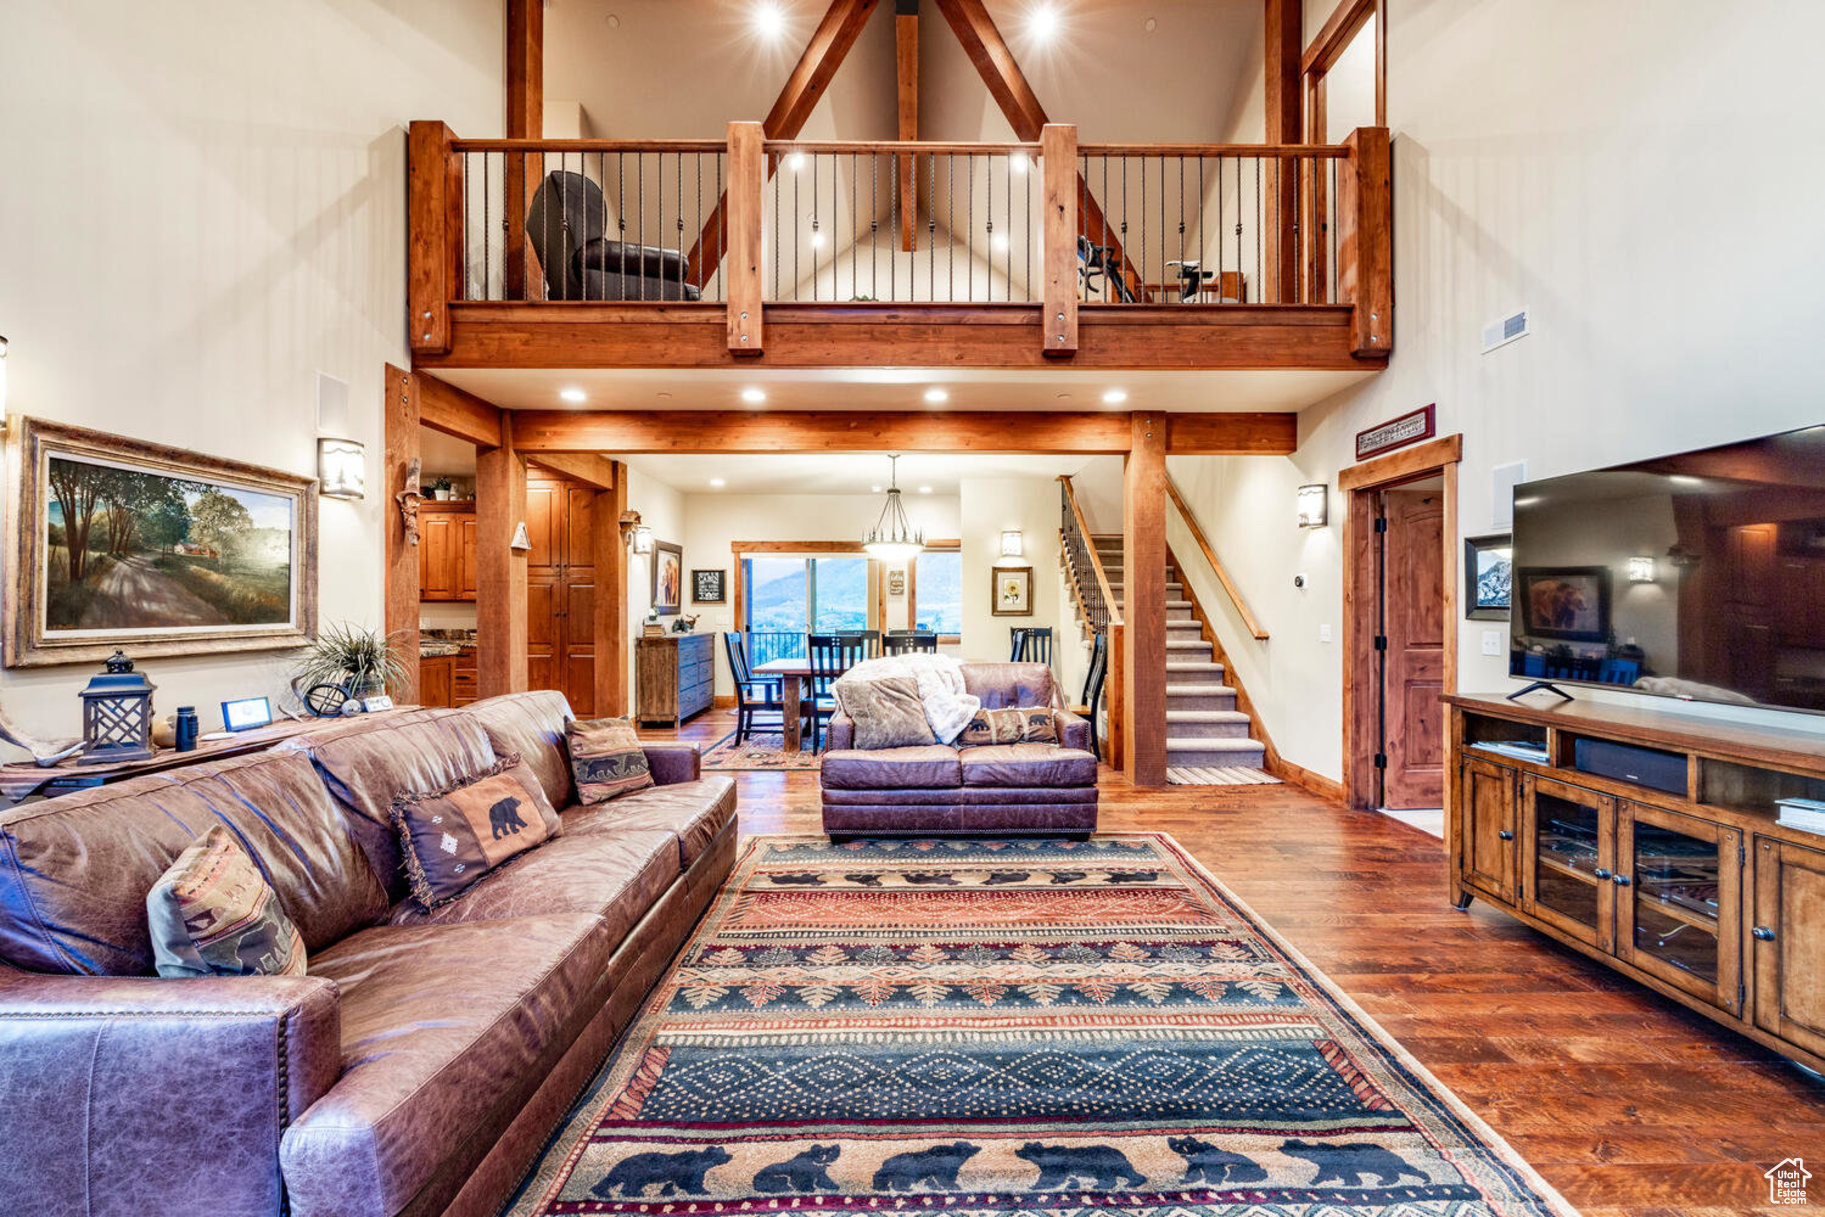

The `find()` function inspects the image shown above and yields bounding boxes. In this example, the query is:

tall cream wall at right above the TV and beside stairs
[1172,0,1825,777]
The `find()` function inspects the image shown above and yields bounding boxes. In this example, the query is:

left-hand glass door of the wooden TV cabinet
[1522,774,1615,951]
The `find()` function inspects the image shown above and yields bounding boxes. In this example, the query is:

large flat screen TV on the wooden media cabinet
[1509,425,1825,713]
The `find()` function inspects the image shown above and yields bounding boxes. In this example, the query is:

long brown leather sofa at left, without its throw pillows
[0,692,735,1217]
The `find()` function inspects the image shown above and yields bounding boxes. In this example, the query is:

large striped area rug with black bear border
[509,834,1571,1217]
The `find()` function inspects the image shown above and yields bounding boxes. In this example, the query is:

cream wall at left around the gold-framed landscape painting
[0,0,504,748]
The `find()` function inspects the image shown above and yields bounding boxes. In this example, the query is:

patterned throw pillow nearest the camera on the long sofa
[146,825,305,976]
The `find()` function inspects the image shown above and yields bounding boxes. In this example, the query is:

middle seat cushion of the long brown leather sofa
[389,828,681,945]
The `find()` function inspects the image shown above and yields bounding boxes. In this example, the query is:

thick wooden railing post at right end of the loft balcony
[1338,126,1394,356]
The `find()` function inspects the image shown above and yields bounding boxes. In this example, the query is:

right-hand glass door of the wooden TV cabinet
[1613,803,1743,1014]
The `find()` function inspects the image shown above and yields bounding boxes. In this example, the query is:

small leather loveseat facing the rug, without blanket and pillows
[819,664,1097,837]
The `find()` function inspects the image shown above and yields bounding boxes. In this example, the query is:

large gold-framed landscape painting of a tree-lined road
[5,420,318,668]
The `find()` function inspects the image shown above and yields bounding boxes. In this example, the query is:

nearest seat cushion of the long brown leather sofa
[279,914,619,1217]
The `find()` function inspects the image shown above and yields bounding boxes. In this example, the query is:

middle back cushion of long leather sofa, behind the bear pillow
[279,710,495,901]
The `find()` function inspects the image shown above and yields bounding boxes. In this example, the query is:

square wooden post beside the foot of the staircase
[1122,411,1166,786]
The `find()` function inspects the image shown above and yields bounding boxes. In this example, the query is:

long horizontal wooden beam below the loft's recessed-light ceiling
[513,411,1298,456]
